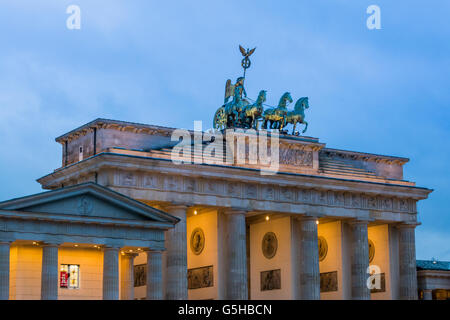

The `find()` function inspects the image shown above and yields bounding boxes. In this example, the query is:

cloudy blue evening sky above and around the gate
[0,0,450,261]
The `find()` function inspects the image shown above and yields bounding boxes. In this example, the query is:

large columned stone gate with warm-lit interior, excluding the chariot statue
[0,119,431,299]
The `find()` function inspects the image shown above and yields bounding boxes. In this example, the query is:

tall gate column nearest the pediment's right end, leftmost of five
[165,205,188,300]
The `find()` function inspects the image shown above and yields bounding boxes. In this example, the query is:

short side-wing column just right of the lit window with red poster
[103,247,119,300]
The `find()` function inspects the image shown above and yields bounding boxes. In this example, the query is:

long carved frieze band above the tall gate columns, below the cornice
[116,172,416,213]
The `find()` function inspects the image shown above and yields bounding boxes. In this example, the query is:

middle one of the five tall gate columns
[297,217,320,300]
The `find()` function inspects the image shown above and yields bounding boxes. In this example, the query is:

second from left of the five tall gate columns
[225,211,248,300]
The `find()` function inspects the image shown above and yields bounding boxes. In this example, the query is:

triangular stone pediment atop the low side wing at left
[0,183,178,223]
